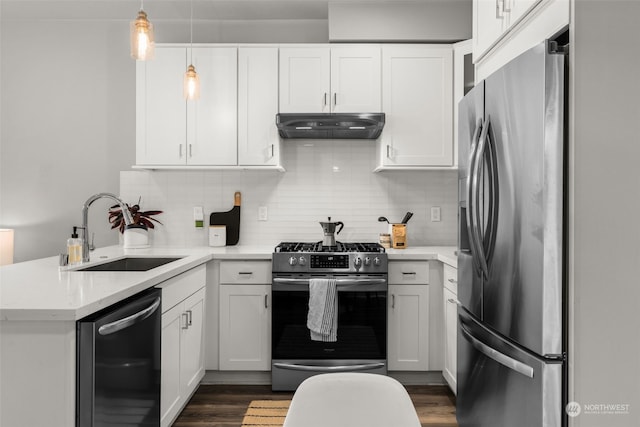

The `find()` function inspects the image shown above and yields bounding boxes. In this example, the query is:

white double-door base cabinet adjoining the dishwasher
[158,265,206,427]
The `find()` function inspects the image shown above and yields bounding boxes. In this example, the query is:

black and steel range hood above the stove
[276,113,384,139]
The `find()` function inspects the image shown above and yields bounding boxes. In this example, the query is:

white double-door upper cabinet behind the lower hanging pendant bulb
[136,46,238,166]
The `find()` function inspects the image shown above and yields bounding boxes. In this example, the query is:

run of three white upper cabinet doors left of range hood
[136,45,282,170]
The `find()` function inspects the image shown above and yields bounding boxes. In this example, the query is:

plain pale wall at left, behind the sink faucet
[0,16,135,262]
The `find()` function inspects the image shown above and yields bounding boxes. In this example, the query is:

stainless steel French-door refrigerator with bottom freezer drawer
[457,41,566,427]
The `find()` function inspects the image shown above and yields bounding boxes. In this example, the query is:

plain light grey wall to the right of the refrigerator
[569,0,640,427]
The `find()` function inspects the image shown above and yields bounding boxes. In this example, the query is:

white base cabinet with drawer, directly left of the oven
[219,261,271,371]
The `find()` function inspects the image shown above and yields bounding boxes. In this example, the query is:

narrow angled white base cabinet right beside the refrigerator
[442,264,458,393]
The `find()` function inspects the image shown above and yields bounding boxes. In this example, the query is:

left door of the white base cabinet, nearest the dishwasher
[160,304,185,427]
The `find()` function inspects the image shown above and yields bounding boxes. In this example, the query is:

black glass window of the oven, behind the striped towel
[271,290,387,359]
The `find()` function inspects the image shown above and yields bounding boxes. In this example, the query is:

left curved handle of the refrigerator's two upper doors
[470,117,491,279]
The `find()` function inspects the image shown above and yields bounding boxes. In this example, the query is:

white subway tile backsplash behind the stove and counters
[120,140,458,246]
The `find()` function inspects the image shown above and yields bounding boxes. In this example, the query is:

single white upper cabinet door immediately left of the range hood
[238,47,280,166]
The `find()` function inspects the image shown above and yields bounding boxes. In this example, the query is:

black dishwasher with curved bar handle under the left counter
[76,289,162,427]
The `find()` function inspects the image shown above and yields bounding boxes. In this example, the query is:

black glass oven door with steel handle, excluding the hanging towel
[271,275,387,390]
